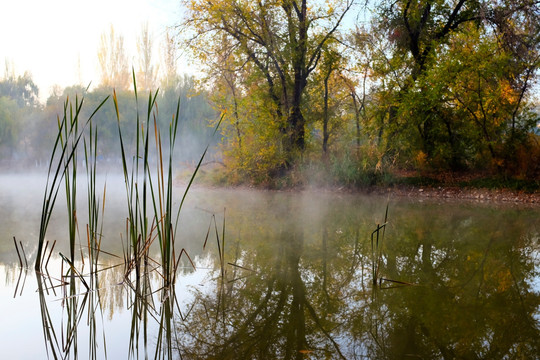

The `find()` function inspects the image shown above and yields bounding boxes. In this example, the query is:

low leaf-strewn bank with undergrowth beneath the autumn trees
[194,166,540,205]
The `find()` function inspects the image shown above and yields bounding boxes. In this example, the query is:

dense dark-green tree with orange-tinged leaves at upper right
[368,0,540,169]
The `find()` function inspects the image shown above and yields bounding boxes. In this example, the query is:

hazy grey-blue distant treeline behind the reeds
[0,74,217,169]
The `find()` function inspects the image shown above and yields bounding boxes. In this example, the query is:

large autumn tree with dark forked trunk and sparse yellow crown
[183,0,354,167]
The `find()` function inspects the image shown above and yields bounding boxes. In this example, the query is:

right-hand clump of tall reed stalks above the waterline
[113,72,223,288]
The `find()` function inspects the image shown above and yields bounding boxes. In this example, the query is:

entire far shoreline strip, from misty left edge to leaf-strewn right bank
[0,155,540,205]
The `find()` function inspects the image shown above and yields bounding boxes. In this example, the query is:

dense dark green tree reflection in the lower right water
[353,201,540,359]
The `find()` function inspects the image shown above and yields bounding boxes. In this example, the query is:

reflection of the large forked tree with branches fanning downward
[178,201,360,359]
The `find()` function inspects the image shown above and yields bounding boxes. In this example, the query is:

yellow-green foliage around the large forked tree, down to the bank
[183,0,354,172]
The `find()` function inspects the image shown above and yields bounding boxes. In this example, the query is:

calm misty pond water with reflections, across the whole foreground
[0,175,540,359]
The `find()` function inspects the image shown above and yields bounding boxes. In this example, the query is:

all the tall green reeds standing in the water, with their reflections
[31,79,225,358]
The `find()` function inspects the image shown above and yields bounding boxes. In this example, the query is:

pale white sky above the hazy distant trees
[0,0,182,100]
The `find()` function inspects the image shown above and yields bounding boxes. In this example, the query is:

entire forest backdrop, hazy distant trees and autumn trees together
[0,0,540,186]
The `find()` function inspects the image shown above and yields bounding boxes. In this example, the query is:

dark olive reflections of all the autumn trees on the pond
[177,201,540,359]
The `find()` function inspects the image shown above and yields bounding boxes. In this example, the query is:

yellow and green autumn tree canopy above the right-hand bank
[180,0,540,181]
